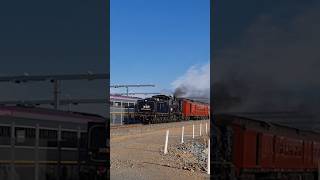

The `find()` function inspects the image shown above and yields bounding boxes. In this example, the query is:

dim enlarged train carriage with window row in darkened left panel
[0,107,109,180]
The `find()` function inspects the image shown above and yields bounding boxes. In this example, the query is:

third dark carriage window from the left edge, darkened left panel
[39,129,58,147]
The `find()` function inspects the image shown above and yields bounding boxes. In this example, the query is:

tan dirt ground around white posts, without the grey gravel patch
[110,121,209,180]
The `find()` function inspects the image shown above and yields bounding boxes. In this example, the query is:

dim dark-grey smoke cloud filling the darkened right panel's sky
[213,1,320,128]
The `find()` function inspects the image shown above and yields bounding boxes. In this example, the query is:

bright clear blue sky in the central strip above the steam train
[110,0,210,92]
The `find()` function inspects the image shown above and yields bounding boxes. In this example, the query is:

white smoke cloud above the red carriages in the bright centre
[171,63,210,102]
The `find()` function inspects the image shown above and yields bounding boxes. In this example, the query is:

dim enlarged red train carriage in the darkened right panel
[212,114,320,179]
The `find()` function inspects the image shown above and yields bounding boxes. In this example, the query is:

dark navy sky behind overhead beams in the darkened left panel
[0,0,109,115]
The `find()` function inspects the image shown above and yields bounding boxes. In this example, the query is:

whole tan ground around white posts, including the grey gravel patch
[110,121,209,180]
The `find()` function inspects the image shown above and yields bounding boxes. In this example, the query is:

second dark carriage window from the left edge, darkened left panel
[15,127,36,146]
